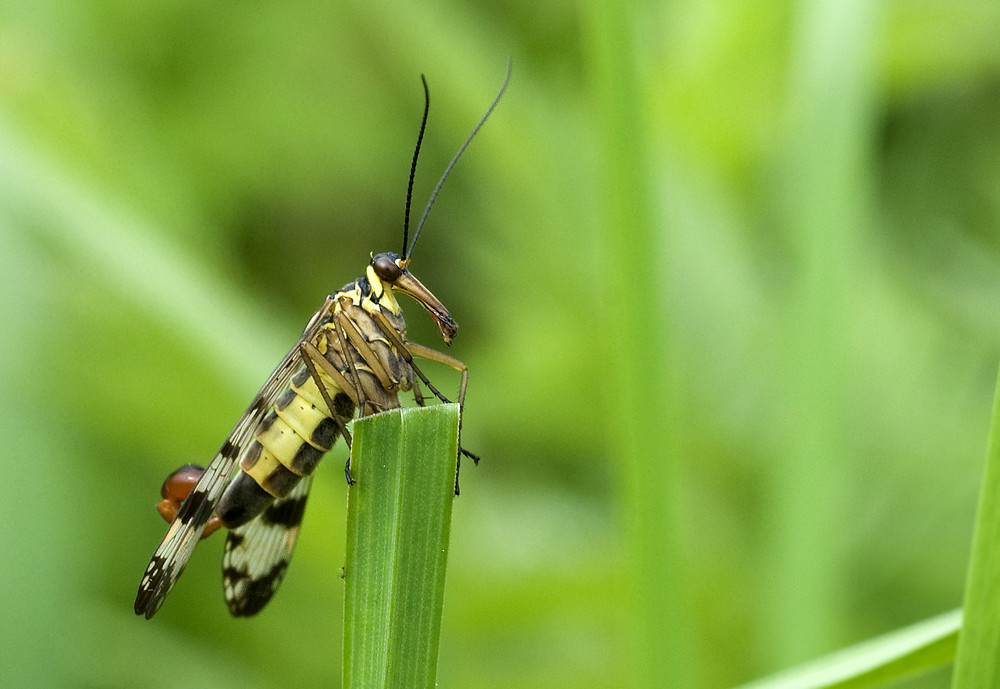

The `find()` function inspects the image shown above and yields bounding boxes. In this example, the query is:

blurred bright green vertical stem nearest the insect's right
[587,0,691,688]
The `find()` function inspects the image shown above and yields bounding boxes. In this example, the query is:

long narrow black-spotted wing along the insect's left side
[135,299,333,619]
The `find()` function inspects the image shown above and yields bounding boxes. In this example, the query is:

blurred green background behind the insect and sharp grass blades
[0,0,1000,689]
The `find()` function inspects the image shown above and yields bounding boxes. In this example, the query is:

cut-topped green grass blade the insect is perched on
[343,404,458,689]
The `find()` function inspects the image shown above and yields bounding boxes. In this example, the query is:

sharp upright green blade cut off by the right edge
[952,362,1000,689]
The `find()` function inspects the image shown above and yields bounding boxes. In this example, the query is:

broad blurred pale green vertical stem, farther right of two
[763,0,879,666]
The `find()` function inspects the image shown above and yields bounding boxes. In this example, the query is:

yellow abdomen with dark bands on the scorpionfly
[216,367,354,528]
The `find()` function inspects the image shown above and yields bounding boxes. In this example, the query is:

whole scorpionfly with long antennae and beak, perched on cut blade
[135,64,511,619]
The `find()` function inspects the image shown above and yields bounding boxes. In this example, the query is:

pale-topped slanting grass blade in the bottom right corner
[737,610,960,689]
